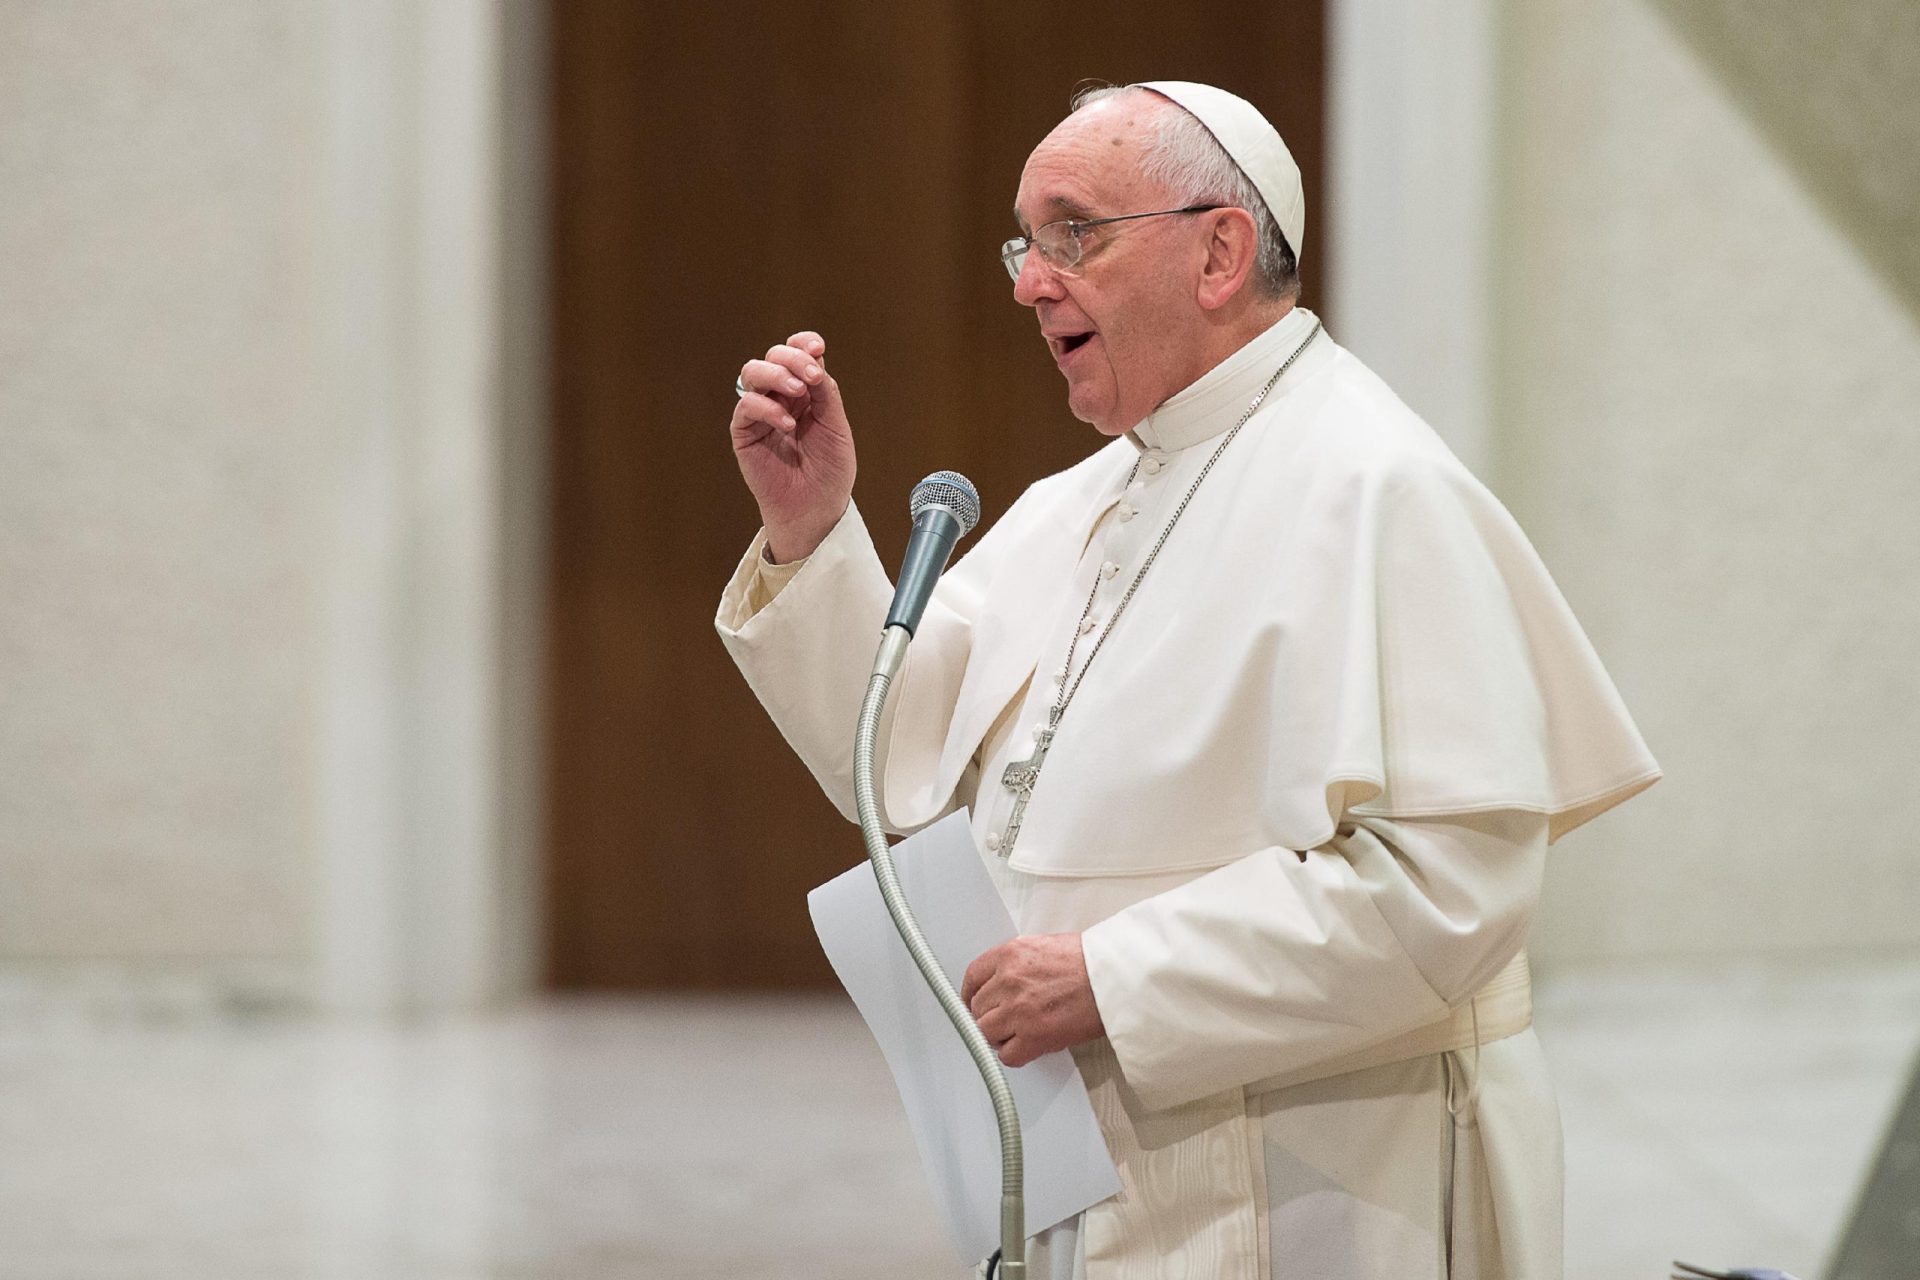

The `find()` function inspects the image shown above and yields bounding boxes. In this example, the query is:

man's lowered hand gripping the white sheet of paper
[960,933,1106,1067]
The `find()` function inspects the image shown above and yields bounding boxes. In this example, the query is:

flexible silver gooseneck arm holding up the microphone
[852,626,1027,1280]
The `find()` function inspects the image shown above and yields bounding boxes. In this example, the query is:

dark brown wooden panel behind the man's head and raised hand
[545,0,1327,988]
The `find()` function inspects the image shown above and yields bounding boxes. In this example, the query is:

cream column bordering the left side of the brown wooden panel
[317,0,540,1011]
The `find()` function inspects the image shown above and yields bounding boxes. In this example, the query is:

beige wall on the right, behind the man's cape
[1490,0,1920,960]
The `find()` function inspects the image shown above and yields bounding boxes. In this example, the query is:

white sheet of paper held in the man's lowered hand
[806,810,1119,1263]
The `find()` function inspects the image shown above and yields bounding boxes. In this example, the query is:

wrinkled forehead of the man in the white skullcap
[1014,94,1160,230]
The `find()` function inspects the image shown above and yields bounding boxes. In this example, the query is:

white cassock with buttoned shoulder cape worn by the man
[716,309,1659,1280]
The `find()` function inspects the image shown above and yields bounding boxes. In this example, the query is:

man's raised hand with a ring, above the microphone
[730,330,854,562]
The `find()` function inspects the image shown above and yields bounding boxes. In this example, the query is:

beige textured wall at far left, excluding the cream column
[0,4,324,979]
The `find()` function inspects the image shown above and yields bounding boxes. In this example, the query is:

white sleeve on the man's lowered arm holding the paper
[1081,810,1548,1107]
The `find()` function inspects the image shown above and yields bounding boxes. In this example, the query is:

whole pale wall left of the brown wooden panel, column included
[0,0,538,1007]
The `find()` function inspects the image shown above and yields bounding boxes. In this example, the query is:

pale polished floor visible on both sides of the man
[0,960,1920,1280]
